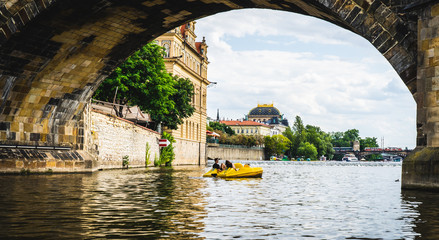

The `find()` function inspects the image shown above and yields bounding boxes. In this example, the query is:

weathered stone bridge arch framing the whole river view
[0,0,439,189]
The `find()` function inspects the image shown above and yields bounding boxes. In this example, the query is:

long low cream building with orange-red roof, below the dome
[220,121,271,136]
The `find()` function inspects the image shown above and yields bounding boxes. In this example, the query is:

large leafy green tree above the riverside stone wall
[94,43,194,129]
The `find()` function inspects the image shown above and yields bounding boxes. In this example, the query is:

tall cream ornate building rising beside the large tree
[156,22,210,165]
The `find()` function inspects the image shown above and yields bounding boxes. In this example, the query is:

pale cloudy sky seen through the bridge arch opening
[195,9,416,148]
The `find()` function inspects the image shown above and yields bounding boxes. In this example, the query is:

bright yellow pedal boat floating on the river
[203,163,263,178]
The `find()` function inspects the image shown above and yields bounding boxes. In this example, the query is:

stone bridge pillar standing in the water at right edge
[402,1,439,190]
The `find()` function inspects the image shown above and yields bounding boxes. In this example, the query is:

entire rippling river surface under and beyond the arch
[0,162,439,239]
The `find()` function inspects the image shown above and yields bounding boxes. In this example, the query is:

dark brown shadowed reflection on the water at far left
[0,175,84,239]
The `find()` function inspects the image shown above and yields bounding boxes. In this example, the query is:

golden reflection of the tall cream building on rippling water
[78,168,205,239]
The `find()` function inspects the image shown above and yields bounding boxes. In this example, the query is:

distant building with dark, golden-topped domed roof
[246,104,289,135]
